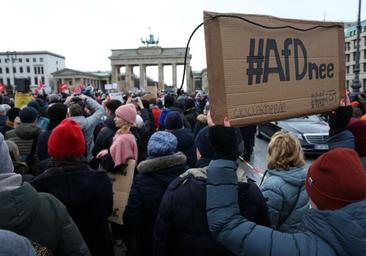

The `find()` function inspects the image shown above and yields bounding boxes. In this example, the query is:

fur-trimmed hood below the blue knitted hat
[137,152,187,173]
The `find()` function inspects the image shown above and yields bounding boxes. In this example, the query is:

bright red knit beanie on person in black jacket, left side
[48,119,85,158]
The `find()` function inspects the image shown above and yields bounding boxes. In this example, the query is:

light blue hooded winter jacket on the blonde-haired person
[261,166,309,233]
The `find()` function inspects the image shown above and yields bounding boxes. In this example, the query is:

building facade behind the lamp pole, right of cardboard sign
[345,20,366,91]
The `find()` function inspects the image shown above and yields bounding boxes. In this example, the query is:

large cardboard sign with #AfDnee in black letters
[204,12,345,126]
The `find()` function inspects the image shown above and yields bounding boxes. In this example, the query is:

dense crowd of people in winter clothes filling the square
[0,88,366,256]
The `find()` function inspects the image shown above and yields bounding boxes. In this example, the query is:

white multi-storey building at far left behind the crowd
[0,51,65,88]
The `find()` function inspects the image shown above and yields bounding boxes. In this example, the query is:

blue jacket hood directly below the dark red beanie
[302,200,366,256]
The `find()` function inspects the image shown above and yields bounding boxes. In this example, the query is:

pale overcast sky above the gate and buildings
[0,0,366,85]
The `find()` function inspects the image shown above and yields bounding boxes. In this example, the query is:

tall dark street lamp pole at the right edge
[350,0,361,100]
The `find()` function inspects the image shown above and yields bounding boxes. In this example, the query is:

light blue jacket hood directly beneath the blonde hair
[268,166,307,187]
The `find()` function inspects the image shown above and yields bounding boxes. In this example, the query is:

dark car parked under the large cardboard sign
[257,115,329,154]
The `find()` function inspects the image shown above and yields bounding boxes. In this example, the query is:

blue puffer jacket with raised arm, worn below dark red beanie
[206,160,366,256]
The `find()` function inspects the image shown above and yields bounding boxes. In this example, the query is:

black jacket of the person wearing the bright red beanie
[31,164,114,255]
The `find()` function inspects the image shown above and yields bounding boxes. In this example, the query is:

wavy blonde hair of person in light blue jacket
[267,131,305,170]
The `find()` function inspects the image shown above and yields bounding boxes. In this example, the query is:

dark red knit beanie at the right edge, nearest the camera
[305,148,366,210]
